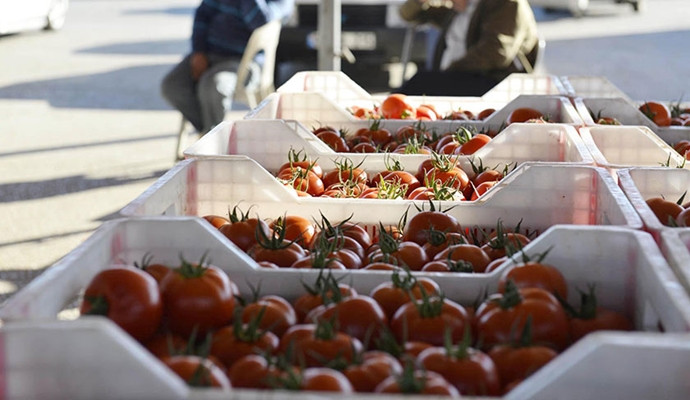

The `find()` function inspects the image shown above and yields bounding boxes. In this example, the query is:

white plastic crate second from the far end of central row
[244,92,583,131]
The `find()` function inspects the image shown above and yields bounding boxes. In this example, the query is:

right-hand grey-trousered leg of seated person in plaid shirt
[196,59,239,133]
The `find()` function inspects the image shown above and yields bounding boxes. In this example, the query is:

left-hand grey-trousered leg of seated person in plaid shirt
[161,56,203,132]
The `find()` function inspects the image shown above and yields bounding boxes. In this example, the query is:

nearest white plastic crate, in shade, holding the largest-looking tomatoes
[0,217,690,399]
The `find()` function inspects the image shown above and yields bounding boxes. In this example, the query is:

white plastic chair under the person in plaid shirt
[175,20,282,160]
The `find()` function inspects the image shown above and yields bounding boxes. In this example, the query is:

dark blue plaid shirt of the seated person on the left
[192,0,294,56]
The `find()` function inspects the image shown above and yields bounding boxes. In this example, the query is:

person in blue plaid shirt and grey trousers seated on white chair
[161,0,294,133]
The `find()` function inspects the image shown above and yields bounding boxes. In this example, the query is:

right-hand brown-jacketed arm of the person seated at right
[448,0,526,71]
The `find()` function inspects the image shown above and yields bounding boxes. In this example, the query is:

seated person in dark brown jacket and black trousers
[398,0,539,96]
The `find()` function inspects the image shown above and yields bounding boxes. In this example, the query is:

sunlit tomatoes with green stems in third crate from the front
[275,148,512,201]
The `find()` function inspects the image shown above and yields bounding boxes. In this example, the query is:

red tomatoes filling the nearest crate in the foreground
[81,225,632,397]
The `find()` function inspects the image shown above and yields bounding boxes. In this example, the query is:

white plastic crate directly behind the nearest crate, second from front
[121,156,642,231]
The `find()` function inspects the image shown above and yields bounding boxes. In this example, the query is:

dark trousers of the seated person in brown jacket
[394,71,499,96]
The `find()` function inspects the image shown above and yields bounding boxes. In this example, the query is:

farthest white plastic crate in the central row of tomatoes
[276,71,568,106]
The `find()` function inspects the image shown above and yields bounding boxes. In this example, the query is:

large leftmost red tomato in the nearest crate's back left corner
[79,266,163,342]
